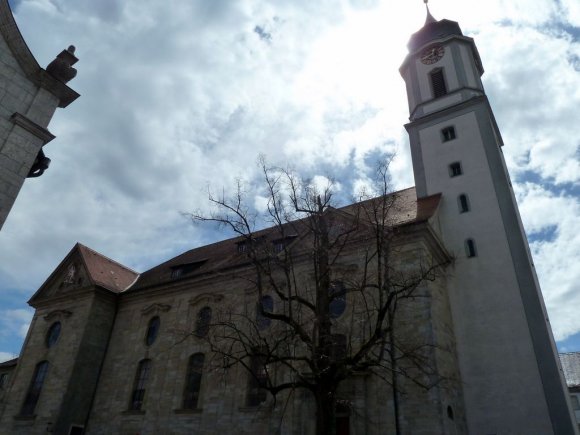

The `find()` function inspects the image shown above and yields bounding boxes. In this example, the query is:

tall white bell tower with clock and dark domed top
[400,4,577,435]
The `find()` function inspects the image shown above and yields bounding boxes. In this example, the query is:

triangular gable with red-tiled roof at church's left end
[28,243,138,306]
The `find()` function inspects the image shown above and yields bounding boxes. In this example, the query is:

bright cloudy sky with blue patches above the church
[0,0,580,360]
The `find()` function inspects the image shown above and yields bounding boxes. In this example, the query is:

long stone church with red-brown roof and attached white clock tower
[0,4,578,435]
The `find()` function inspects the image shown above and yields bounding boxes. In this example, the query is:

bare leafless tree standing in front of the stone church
[191,160,445,435]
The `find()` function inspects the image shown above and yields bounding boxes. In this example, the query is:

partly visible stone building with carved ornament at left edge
[0,0,79,229]
